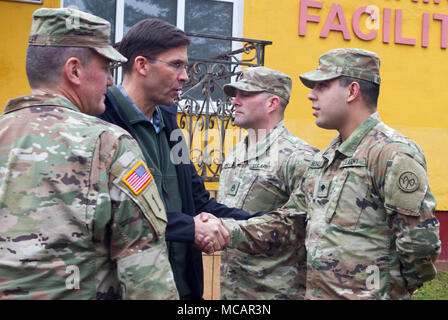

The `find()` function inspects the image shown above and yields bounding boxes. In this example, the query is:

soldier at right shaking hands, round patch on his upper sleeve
[222,48,441,299]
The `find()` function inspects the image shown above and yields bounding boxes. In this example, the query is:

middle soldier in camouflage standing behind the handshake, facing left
[218,67,317,300]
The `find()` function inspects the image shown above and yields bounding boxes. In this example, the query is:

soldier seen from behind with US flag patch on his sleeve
[0,8,177,299]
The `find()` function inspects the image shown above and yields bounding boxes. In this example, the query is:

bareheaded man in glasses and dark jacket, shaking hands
[100,19,250,299]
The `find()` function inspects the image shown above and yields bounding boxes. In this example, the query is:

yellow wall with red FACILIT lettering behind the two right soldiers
[244,0,448,210]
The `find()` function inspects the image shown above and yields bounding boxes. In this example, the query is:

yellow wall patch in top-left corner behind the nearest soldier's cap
[0,0,60,108]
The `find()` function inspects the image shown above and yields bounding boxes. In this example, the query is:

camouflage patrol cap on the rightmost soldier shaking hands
[299,48,381,89]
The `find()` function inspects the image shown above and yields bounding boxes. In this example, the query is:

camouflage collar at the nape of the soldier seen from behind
[3,94,80,113]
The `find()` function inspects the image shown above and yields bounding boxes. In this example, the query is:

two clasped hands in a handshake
[194,212,230,254]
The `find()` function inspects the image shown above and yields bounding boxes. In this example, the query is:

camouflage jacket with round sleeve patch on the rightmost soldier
[224,113,441,299]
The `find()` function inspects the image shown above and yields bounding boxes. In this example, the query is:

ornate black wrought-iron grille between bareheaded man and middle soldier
[177,33,272,182]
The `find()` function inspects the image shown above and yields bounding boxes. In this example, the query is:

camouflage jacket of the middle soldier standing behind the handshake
[218,121,317,300]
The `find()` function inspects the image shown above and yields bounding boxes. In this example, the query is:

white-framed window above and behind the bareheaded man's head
[61,0,244,58]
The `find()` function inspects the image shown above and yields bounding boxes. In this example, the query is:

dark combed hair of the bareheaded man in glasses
[118,19,190,73]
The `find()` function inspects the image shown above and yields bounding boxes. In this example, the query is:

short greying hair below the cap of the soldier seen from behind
[25,46,95,89]
